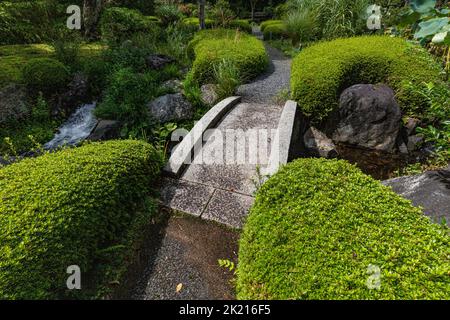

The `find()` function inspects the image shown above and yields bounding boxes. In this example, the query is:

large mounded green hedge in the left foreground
[0,141,161,299]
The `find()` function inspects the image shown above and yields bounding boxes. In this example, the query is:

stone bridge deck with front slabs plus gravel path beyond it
[161,45,291,228]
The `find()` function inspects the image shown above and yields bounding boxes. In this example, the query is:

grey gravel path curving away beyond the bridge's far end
[237,44,291,104]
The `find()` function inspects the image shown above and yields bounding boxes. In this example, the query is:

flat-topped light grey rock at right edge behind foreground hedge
[382,166,450,226]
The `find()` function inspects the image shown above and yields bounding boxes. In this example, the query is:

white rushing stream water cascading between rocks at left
[44,103,97,150]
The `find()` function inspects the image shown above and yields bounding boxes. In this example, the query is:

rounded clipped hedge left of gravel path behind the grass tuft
[188,29,268,84]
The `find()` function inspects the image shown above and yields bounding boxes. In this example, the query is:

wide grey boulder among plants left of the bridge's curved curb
[148,93,194,123]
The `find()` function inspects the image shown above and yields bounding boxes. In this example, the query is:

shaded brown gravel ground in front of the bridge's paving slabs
[124,212,239,300]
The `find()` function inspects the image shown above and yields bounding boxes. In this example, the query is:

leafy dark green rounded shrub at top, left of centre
[100,7,157,43]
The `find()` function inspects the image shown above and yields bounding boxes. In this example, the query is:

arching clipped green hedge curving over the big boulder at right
[291,36,440,121]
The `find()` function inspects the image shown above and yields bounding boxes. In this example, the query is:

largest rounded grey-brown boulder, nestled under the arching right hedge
[332,84,402,152]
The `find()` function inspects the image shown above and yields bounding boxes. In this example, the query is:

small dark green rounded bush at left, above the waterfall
[22,58,69,93]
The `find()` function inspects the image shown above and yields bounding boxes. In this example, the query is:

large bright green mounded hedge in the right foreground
[237,159,450,299]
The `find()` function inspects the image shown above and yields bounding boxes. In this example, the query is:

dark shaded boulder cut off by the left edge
[0,84,30,124]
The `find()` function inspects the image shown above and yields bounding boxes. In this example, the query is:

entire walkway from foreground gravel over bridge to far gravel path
[128,41,291,299]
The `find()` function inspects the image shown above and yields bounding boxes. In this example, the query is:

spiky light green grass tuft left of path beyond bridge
[214,59,241,101]
